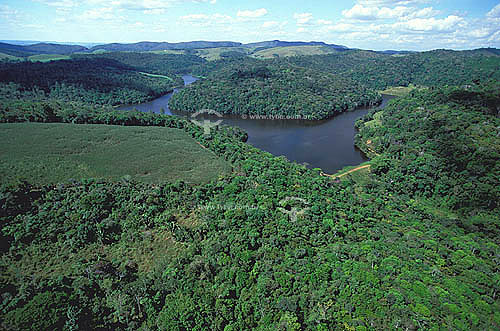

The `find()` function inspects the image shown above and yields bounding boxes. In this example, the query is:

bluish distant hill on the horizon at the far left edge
[0,43,87,57]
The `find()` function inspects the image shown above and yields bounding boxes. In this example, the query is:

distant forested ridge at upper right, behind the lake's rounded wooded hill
[288,50,500,90]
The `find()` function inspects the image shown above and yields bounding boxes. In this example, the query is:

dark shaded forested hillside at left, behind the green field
[0,58,182,105]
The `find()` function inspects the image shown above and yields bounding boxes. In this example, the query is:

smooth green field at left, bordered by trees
[0,123,231,185]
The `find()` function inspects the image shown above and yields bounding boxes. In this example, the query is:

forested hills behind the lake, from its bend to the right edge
[171,50,500,119]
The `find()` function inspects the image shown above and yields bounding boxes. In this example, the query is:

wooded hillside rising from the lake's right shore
[358,83,500,211]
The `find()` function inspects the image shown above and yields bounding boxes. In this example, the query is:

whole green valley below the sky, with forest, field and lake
[0,41,500,331]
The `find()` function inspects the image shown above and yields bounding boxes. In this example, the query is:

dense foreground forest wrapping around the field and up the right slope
[0,81,500,330]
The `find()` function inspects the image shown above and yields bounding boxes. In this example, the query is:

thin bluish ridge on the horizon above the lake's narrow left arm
[90,41,241,52]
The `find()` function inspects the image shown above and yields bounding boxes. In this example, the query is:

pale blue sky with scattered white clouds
[0,0,500,51]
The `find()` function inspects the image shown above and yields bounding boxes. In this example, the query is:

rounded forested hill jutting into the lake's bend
[169,59,380,119]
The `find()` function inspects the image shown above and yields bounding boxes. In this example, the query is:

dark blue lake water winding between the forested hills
[119,76,391,173]
